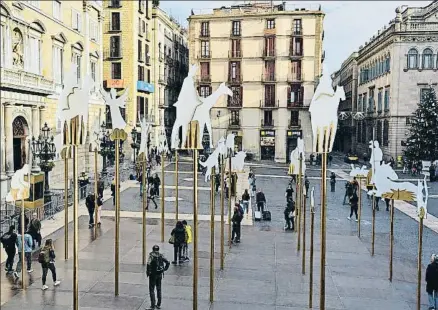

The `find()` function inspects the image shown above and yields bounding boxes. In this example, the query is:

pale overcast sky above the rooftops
[160,0,432,72]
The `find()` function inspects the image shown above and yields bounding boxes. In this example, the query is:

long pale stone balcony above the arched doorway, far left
[1,68,55,95]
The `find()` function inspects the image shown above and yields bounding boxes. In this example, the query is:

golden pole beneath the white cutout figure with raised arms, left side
[114,139,120,296]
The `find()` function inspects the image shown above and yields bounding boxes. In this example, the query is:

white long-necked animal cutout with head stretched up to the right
[193,83,233,148]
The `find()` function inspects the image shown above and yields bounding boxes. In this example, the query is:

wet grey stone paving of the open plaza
[1,156,438,310]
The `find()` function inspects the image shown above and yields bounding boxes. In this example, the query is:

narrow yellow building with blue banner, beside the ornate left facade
[103,0,157,144]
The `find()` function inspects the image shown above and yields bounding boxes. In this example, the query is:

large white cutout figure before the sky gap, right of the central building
[309,68,345,153]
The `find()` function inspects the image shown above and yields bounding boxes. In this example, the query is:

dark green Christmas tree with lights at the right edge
[405,87,438,162]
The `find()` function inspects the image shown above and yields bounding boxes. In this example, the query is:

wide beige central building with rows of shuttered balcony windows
[188,3,324,162]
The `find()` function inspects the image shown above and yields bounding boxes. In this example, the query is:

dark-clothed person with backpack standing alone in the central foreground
[146,245,170,309]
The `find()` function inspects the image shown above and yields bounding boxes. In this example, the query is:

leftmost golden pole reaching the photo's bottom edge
[72,144,79,310]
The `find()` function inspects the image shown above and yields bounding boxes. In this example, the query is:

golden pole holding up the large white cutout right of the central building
[319,151,327,310]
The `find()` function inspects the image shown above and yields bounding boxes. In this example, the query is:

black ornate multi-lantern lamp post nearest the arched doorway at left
[31,123,56,202]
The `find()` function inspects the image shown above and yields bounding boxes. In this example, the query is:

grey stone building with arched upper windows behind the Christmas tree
[353,1,438,160]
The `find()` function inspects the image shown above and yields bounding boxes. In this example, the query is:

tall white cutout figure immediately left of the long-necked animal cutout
[171,65,202,149]
